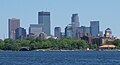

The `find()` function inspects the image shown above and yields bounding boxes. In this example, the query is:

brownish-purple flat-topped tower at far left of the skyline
[8,18,20,39]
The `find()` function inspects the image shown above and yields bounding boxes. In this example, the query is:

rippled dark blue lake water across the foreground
[0,51,120,65]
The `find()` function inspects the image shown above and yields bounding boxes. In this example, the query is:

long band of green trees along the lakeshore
[0,38,101,51]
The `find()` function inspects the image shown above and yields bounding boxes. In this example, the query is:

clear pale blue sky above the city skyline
[0,0,120,39]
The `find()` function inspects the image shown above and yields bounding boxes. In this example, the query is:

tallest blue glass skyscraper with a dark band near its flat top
[38,11,51,36]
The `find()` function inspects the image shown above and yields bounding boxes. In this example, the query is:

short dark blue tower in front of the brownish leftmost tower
[15,27,26,39]
